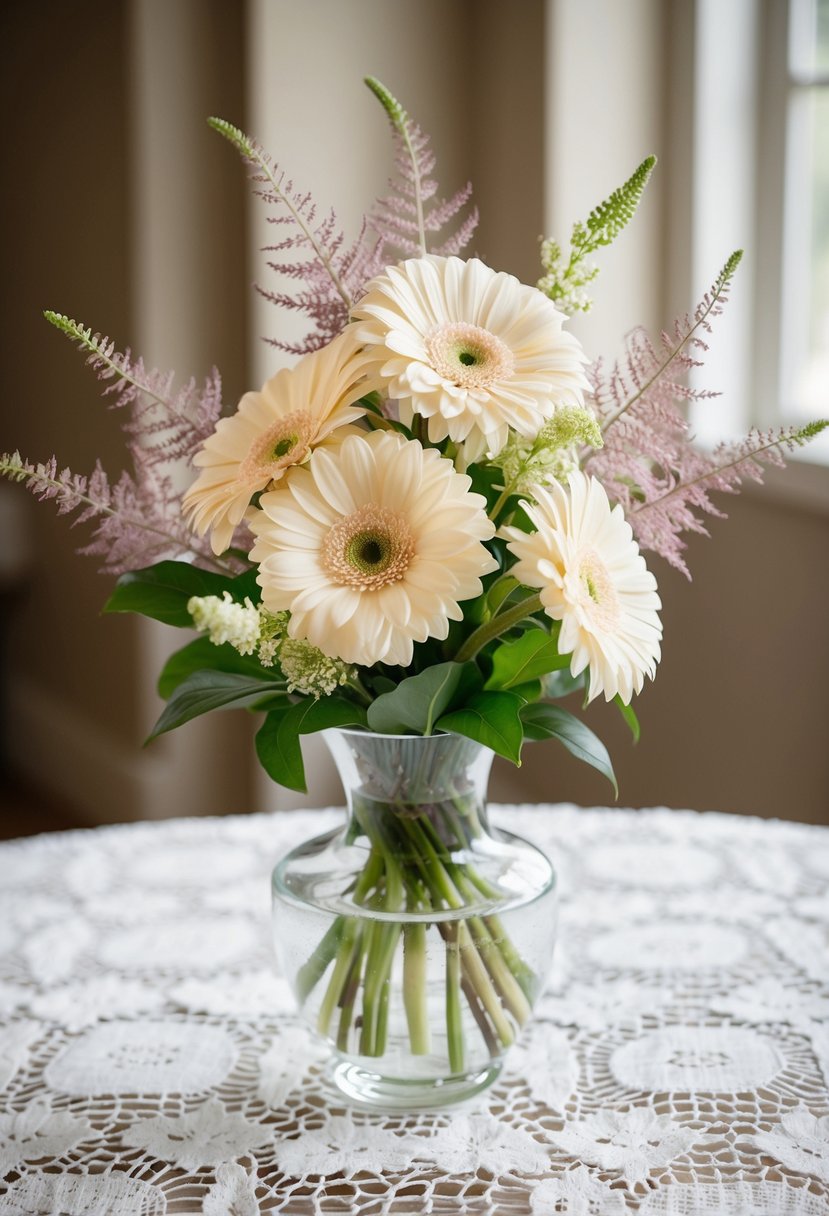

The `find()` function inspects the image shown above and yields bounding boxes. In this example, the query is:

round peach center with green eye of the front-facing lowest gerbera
[321,502,415,591]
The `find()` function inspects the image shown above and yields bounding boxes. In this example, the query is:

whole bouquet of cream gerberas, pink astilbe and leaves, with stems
[0,79,827,1094]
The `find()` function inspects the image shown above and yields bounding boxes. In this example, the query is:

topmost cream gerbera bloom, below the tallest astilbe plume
[353,257,590,463]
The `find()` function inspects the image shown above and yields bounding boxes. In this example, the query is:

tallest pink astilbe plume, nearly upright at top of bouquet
[366,77,478,263]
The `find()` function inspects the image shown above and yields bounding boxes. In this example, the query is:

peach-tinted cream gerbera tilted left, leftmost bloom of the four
[184,327,372,553]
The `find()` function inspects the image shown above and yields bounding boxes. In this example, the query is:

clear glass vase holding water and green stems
[273,731,557,1110]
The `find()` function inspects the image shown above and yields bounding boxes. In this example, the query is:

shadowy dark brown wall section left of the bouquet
[0,0,250,820]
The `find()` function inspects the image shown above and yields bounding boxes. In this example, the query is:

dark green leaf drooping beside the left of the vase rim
[255,697,366,794]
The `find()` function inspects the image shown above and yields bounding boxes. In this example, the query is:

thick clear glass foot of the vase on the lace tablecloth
[328,1059,501,1111]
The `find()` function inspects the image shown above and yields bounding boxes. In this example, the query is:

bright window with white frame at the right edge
[690,0,829,465]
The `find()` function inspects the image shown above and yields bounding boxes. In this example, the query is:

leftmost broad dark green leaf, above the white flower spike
[103,562,255,629]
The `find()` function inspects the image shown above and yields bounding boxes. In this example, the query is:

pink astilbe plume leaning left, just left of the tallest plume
[209,118,382,355]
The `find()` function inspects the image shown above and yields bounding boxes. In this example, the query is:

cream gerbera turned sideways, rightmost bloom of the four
[500,472,662,704]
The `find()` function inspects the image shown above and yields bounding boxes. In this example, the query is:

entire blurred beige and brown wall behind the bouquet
[0,0,829,821]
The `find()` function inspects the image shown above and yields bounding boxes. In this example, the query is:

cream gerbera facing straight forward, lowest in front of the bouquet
[250,432,497,666]
